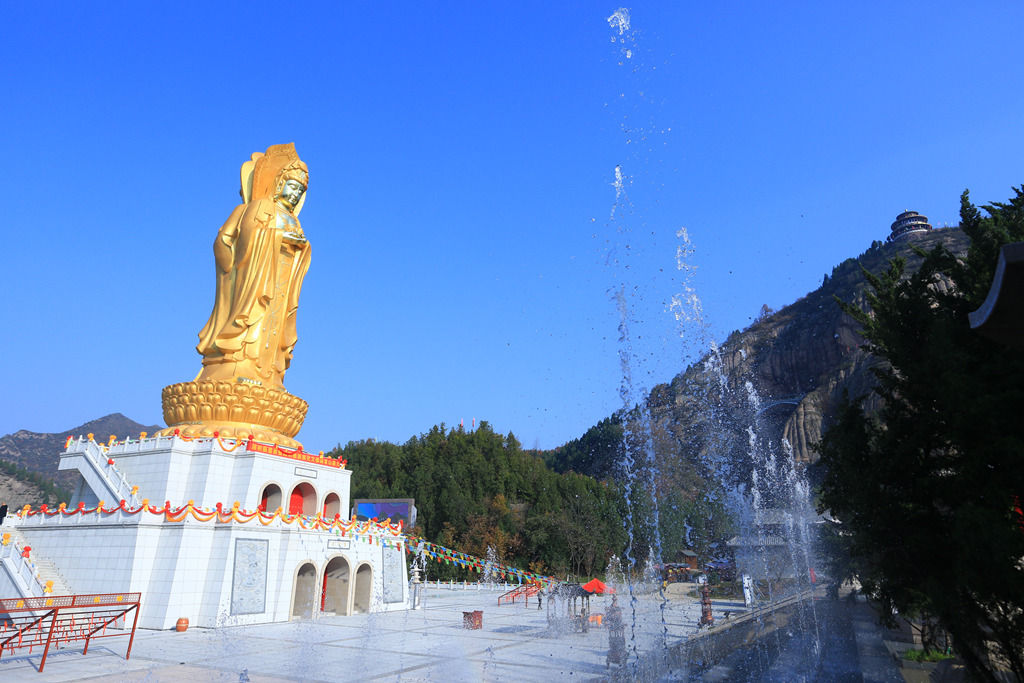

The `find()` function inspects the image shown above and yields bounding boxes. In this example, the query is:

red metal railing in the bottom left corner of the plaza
[0,593,141,672]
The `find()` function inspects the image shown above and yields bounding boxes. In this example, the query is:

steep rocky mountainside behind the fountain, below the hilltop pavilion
[545,228,968,488]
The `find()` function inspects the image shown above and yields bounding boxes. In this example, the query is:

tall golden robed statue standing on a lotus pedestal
[155,143,309,446]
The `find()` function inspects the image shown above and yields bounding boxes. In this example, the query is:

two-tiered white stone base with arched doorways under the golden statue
[8,437,409,629]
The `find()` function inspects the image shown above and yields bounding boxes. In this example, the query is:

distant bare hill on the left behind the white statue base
[0,413,163,507]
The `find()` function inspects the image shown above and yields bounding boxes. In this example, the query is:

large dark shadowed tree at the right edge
[818,188,1024,681]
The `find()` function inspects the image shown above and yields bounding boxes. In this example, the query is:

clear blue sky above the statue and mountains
[0,2,1024,451]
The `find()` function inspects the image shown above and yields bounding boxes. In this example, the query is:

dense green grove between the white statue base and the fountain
[332,421,626,579]
